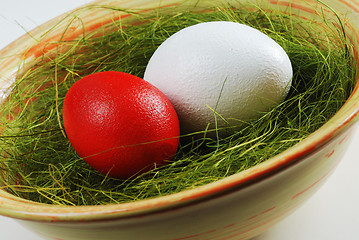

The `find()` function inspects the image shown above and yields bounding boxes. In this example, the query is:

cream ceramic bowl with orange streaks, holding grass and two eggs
[0,0,359,240]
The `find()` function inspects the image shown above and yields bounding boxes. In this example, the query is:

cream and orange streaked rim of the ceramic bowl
[0,1,359,222]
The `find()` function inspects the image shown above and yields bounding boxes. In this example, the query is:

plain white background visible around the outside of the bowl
[0,0,359,240]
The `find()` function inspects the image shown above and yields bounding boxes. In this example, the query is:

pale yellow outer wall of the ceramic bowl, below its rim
[14,128,358,240]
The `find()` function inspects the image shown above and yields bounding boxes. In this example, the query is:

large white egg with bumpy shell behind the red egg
[144,21,293,133]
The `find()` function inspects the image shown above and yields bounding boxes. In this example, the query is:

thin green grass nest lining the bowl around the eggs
[0,0,356,205]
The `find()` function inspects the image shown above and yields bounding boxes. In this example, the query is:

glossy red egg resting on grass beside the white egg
[63,71,179,179]
